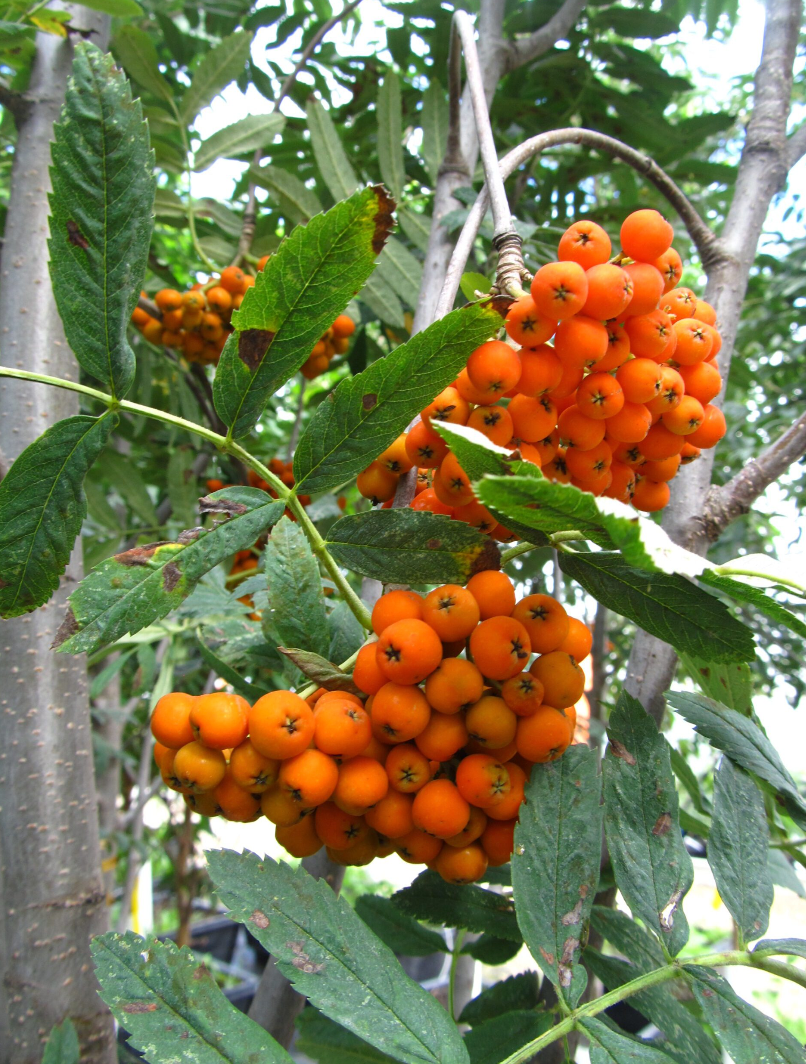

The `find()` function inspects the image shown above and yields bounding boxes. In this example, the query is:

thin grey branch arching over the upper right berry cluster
[436,128,723,318]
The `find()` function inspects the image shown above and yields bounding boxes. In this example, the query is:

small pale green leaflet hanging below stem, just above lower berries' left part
[264,517,330,661]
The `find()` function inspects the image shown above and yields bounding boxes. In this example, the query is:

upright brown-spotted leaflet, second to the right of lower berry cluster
[602,692,694,957]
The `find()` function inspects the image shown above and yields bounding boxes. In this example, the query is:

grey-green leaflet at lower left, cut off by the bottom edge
[89,931,291,1064]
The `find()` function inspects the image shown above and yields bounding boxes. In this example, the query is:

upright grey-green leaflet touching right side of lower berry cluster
[513,745,602,1009]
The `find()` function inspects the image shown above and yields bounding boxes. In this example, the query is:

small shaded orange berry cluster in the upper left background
[132,260,255,365]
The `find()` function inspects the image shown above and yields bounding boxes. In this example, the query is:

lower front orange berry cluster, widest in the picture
[151,570,591,883]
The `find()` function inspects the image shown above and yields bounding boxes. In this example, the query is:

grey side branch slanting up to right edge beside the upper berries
[703,414,806,541]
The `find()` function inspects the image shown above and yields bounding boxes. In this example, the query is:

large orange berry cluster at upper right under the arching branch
[357,210,726,517]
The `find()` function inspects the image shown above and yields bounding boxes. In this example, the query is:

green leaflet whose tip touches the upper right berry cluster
[293,302,501,495]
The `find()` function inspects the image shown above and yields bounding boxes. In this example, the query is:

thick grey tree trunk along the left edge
[0,6,116,1064]
